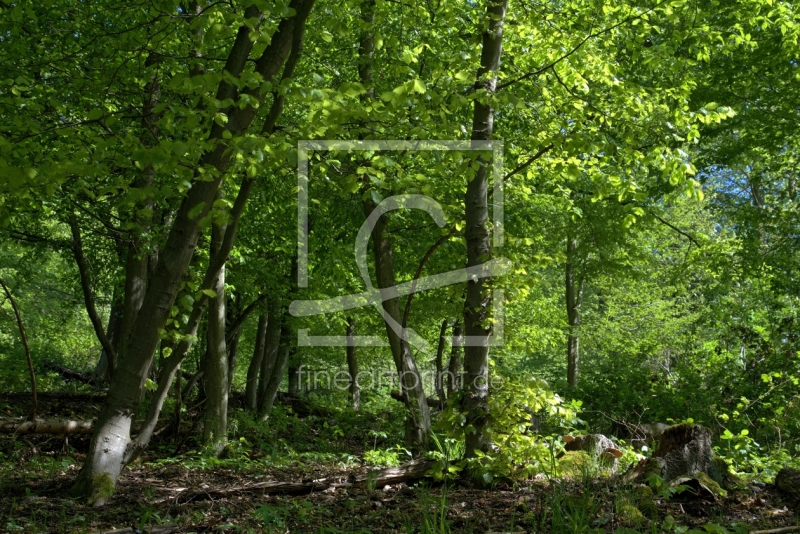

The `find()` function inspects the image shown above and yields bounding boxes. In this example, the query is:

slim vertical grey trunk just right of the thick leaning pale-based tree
[203,203,228,453]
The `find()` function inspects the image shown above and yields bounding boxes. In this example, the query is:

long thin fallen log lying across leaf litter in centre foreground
[165,460,435,503]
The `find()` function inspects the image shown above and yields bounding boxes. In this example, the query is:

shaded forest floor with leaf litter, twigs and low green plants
[0,396,800,534]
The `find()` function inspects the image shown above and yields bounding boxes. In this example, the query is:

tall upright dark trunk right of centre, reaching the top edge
[462,0,508,458]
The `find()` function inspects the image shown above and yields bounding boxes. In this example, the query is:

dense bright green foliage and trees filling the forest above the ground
[0,0,800,524]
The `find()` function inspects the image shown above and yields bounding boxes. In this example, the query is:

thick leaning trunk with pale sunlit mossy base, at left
[72,0,314,506]
